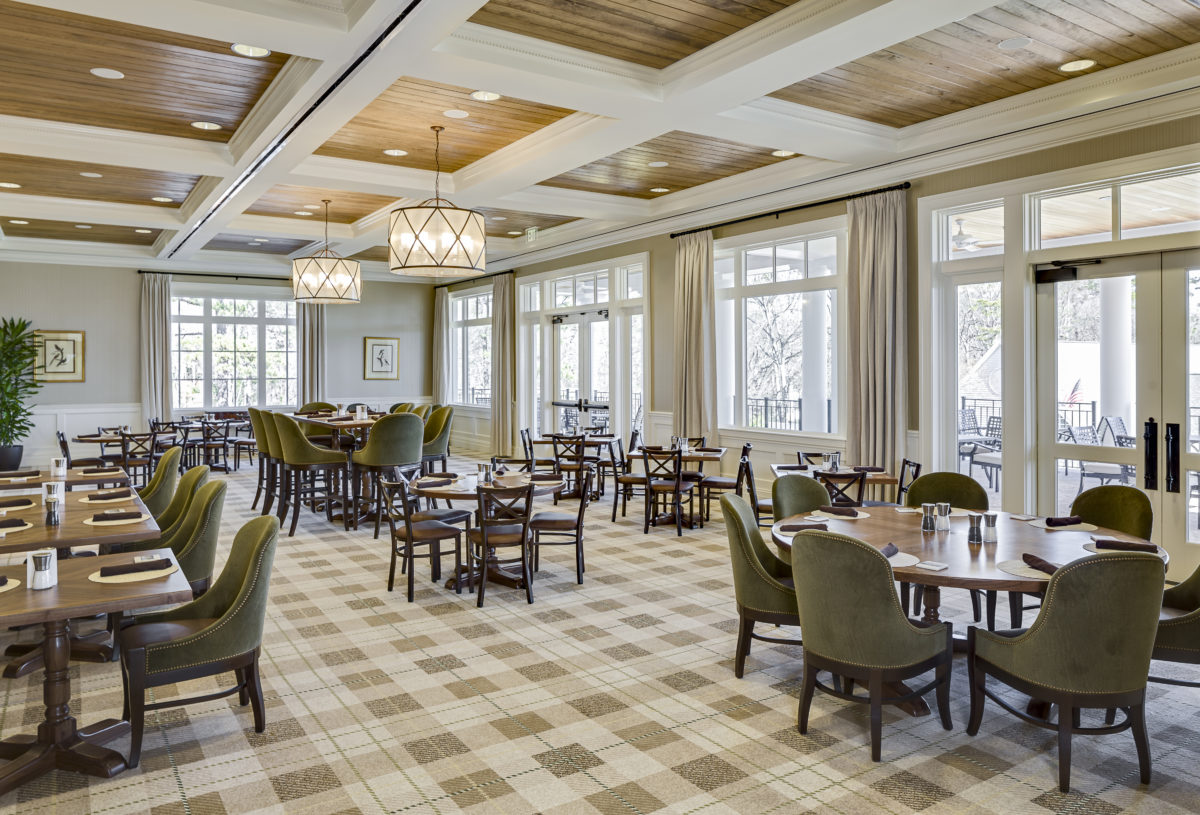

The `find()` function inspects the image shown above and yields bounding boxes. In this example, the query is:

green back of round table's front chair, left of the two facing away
[792,531,946,669]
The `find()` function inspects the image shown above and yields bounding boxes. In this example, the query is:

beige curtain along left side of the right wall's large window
[672,230,716,442]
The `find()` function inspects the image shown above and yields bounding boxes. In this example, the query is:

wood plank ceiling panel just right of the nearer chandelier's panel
[542,131,787,198]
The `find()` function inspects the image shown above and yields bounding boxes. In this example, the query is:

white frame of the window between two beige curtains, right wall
[713,215,848,443]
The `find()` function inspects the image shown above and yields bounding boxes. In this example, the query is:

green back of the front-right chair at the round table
[1009,552,1165,694]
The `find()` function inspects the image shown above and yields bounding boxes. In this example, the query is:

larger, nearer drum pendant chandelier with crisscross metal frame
[388,126,487,277]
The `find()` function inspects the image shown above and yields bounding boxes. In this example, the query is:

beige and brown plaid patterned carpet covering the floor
[0,453,1200,815]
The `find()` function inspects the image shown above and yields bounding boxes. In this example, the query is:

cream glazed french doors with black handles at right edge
[1037,251,1200,579]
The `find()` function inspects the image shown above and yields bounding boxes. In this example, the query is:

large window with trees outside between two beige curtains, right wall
[715,218,845,433]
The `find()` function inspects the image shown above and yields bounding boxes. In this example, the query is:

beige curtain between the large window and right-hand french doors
[846,190,907,473]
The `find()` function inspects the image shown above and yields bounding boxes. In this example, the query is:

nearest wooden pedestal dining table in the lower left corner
[0,549,192,795]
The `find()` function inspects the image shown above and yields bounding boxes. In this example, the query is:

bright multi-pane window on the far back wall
[170,289,298,409]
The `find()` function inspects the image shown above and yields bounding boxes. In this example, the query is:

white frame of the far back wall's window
[169,283,300,415]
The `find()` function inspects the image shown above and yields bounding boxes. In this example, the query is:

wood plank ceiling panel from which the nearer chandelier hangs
[317,77,572,170]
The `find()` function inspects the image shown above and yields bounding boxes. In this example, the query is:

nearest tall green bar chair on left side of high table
[272,413,350,538]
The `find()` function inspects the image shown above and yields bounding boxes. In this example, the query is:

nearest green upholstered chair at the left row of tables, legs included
[121,516,280,767]
